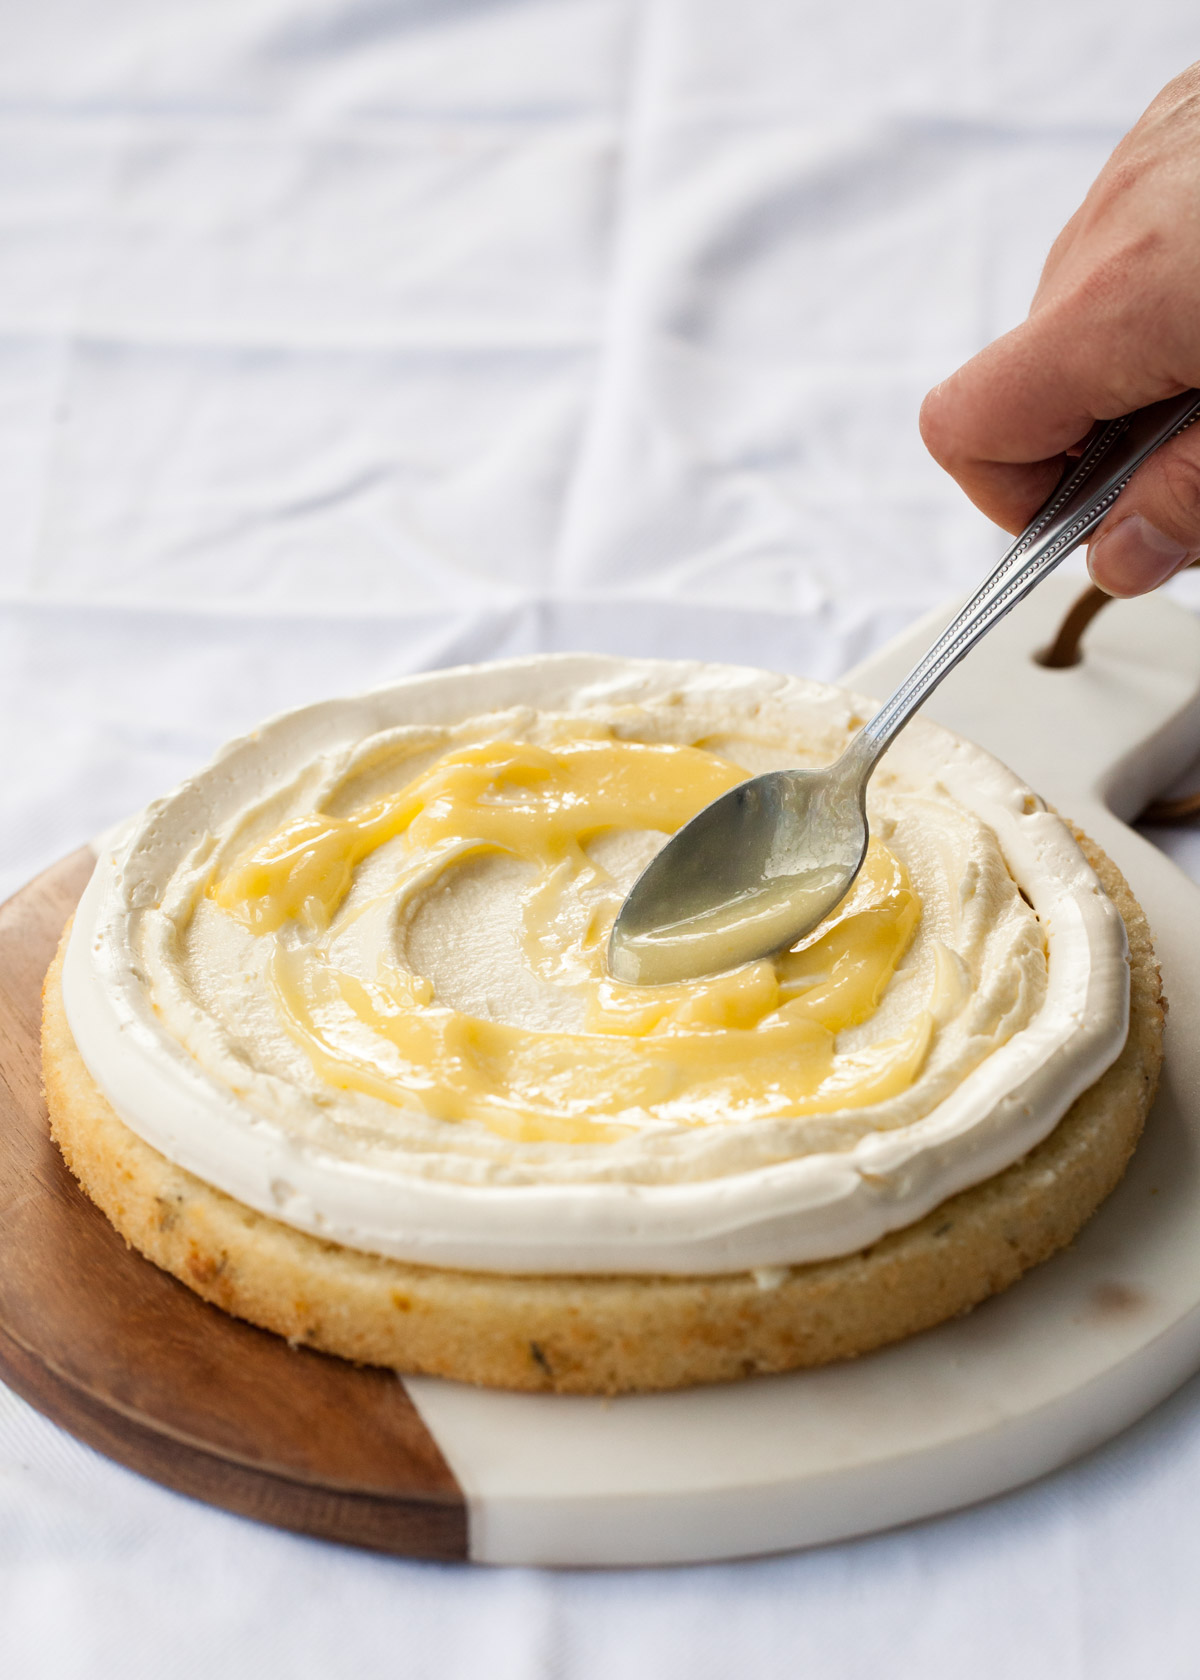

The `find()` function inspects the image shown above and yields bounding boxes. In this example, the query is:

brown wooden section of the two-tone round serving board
[0,848,467,1559]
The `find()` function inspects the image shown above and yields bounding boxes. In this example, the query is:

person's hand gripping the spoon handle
[921,64,1200,595]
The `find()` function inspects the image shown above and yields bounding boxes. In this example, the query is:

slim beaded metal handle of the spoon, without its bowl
[854,390,1200,766]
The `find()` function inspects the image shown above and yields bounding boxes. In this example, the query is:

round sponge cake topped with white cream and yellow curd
[45,657,1163,1391]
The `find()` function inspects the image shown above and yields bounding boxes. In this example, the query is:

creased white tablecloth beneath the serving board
[0,0,1200,1680]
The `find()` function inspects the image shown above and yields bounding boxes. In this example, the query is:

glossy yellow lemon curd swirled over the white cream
[208,738,933,1144]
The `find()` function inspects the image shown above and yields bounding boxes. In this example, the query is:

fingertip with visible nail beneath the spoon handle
[1087,430,1200,595]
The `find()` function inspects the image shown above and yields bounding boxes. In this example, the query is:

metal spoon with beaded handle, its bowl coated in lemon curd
[608,391,1200,986]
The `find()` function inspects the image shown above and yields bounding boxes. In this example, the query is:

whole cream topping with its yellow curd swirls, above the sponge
[64,659,1128,1272]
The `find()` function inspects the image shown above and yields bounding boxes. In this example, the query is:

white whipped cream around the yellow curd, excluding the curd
[64,657,1128,1273]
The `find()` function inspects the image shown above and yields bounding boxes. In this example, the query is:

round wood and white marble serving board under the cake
[9,580,1200,1564]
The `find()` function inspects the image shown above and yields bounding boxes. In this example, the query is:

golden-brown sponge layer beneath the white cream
[42,837,1165,1394]
